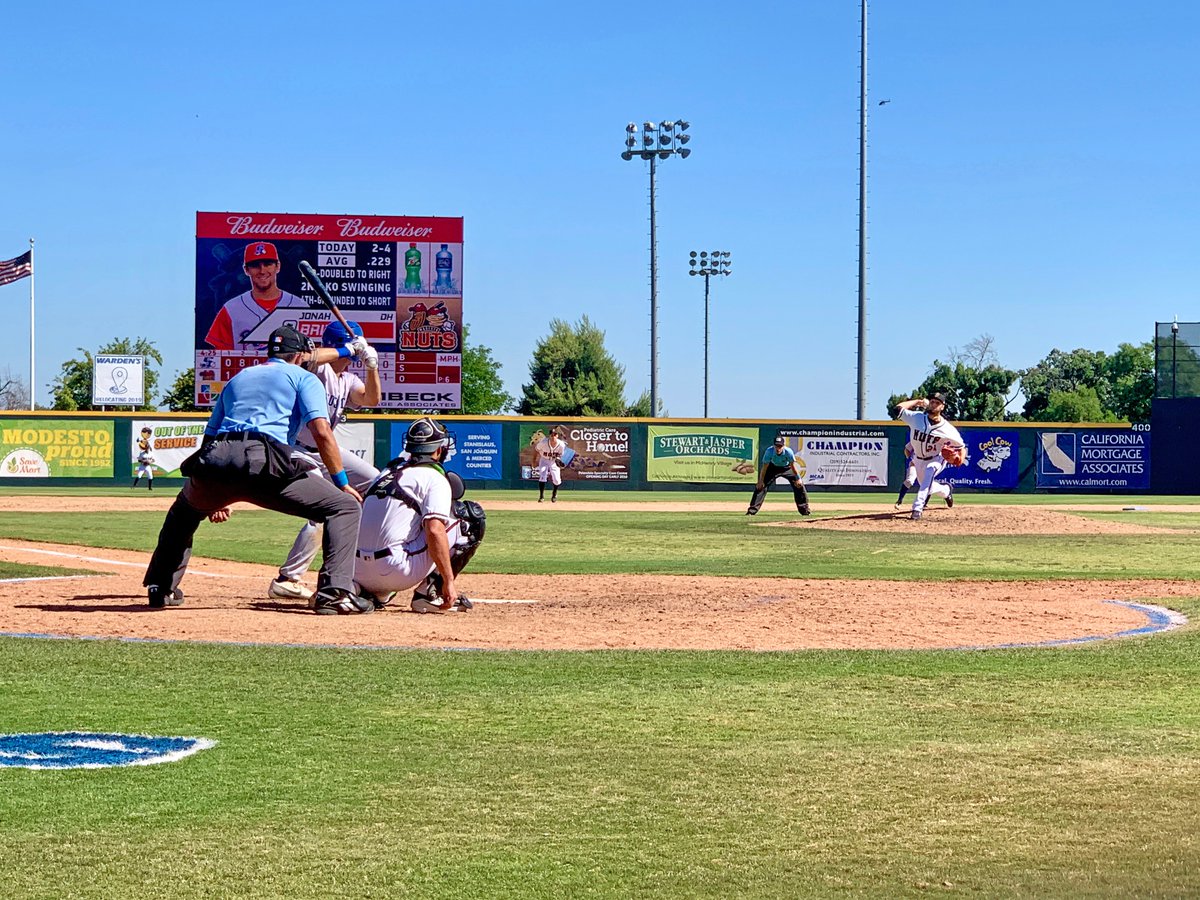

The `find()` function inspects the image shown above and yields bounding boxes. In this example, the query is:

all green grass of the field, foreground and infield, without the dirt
[0,492,1200,900]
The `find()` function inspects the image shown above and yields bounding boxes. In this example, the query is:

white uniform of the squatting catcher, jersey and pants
[354,466,466,596]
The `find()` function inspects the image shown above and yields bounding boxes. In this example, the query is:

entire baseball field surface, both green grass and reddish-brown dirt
[0,488,1200,898]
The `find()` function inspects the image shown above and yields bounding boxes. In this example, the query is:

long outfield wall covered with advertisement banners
[0,415,1161,493]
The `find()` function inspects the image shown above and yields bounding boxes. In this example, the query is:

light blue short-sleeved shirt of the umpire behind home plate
[204,359,329,444]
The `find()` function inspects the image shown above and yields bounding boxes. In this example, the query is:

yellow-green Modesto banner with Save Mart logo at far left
[0,419,113,478]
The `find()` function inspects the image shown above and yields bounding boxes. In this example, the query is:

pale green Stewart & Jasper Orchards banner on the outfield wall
[646,425,758,485]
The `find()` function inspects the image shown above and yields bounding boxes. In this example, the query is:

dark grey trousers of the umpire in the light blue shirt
[142,460,362,590]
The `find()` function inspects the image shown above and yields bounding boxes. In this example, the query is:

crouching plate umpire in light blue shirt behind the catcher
[142,326,374,616]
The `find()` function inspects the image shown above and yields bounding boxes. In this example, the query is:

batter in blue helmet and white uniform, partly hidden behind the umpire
[266,320,383,600]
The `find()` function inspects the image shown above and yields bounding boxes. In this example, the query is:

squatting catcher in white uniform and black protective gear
[354,418,486,613]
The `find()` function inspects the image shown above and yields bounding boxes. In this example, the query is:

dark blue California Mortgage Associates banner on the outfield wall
[1037,428,1150,491]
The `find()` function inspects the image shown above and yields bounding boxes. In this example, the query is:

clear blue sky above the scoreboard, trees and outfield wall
[0,0,1200,419]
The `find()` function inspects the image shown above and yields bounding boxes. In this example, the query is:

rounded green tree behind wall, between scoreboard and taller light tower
[517,316,628,416]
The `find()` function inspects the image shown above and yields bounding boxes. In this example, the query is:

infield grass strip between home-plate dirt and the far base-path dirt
[0,504,1200,581]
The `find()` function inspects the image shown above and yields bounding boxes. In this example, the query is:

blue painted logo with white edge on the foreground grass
[0,731,217,769]
